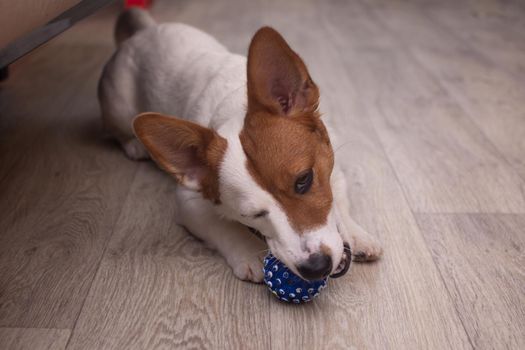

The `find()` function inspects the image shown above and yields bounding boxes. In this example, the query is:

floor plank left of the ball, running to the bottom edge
[68,164,270,349]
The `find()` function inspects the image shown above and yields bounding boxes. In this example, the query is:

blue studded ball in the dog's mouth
[263,253,327,304]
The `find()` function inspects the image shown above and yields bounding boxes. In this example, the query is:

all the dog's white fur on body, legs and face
[99,12,381,282]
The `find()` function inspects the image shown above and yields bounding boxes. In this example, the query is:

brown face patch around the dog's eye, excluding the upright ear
[240,114,334,232]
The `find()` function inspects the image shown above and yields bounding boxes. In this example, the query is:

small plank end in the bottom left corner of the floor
[0,328,71,350]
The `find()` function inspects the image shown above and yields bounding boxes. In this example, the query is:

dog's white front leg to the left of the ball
[176,186,268,283]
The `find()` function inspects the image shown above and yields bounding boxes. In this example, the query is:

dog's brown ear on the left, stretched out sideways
[133,112,227,199]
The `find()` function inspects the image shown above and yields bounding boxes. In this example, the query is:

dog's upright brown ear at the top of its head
[248,27,319,115]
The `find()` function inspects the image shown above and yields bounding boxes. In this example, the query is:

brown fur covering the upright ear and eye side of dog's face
[239,27,334,232]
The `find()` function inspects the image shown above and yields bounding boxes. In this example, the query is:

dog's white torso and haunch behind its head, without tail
[100,18,246,159]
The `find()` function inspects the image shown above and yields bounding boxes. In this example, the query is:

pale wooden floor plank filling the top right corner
[362,3,525,200]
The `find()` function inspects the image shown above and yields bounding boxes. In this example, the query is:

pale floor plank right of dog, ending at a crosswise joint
[331,3,525,212]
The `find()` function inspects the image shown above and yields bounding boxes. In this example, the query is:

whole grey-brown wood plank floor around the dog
[0,0,525,349]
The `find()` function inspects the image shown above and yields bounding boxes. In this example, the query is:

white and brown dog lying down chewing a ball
[98,9,382,282]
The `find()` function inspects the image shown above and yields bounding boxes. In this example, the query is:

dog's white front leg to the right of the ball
[332,169,383,261]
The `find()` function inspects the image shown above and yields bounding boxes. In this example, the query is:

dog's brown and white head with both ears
[134,28,350,280]
